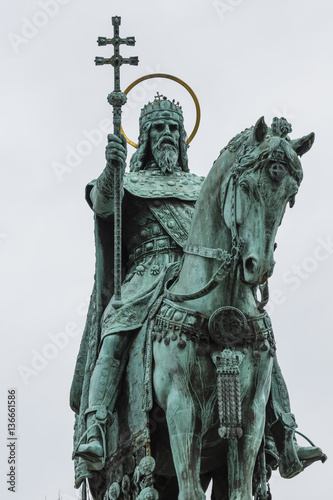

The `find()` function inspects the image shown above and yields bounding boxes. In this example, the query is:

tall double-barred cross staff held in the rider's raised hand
[95,16,139,309]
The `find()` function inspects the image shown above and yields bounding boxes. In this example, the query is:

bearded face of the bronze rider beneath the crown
[150,120,180,174]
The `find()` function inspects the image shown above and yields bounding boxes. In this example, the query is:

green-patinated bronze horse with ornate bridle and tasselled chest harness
[148,118,314,500]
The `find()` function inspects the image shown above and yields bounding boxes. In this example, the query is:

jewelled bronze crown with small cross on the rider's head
[139,92,184,127]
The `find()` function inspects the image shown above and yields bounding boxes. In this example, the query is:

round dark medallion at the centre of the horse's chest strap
[208,306,248,347]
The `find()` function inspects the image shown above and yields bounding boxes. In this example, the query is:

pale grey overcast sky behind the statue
[0,0,333,500]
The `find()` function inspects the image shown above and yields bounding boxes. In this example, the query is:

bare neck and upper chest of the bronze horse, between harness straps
[172,151,256,315]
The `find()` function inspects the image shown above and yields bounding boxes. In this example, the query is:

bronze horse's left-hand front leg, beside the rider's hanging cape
[166,388,206,500]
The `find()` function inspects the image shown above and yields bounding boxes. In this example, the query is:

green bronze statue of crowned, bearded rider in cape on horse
[71,95,326,500]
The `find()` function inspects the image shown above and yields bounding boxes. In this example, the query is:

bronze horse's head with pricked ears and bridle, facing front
[221,117,314,285]
